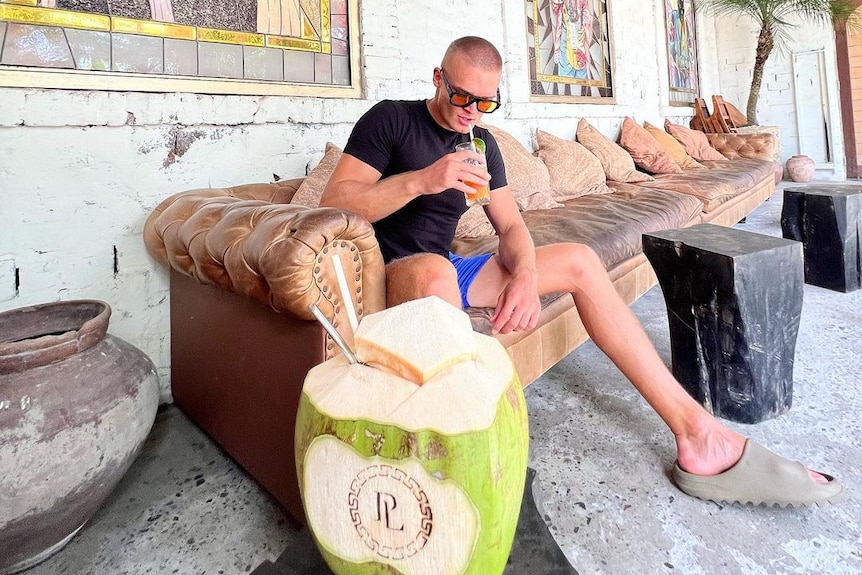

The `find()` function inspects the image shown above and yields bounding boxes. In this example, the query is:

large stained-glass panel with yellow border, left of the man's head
[0,0,360,97]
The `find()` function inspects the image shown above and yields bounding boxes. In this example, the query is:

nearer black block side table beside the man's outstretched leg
[643,224,803,423]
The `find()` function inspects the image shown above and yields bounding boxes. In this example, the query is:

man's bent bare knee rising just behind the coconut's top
[386,254,461,309]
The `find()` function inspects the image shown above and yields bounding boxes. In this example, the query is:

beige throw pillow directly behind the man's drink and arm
[483,125,563,211]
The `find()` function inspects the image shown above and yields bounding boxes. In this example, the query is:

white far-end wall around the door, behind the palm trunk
[706,11,847,180]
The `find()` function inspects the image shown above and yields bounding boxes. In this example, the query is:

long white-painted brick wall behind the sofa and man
[0,0,843,401]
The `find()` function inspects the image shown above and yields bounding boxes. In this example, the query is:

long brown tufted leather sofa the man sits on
[144,128,777,521]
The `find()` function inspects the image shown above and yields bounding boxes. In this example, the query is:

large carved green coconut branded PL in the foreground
[296,298,529,575]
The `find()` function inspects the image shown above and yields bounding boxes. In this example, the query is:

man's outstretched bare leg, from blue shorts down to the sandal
[469,244,825,482]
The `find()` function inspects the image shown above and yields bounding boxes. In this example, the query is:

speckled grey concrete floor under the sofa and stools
[27,187,862,575]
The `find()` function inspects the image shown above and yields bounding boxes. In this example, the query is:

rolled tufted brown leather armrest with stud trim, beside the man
[144,181,386,325]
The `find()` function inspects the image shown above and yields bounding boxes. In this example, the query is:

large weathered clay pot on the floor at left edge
[0,300,159,575]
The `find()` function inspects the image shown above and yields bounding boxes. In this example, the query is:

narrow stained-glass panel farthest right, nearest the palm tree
[664,0,698,106]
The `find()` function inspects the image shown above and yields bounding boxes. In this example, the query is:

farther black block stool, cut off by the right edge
[781,186,862,293]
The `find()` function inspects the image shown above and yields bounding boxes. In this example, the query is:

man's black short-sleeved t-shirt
[344,100,506,263]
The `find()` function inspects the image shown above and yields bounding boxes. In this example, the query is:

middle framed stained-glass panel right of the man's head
[526,0,614,103]
